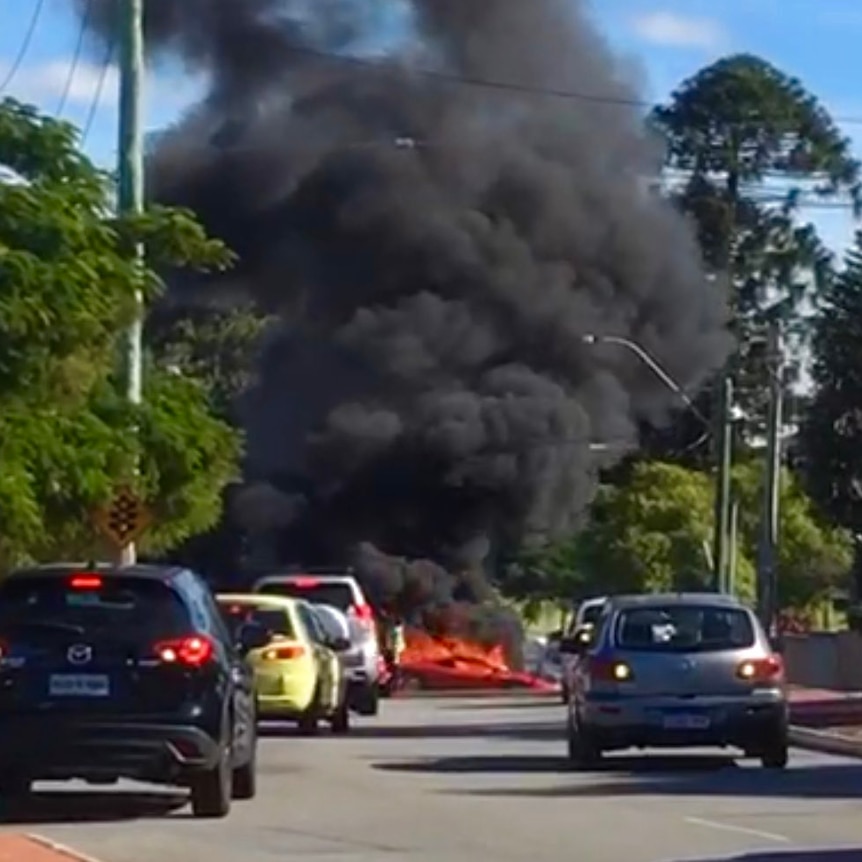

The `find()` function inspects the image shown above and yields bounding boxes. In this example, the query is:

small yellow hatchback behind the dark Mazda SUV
[217,593,350,735]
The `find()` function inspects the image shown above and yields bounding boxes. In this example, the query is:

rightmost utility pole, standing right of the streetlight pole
[757,322,784,632]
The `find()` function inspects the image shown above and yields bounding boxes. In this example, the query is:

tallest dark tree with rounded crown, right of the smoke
[651,54,862,460]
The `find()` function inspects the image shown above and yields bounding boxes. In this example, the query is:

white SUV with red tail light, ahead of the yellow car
[252,571,382,715]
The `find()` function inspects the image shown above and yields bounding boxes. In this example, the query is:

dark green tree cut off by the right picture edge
[801,233,862,588]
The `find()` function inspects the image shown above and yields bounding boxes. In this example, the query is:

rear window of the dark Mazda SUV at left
[0,575,192,643]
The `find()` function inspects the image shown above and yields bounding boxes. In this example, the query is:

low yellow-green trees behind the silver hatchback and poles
[532,461,851,607]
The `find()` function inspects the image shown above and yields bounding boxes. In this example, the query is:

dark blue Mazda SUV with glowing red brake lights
[0,564,268,817]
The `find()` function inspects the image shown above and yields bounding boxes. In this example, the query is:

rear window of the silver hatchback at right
[615,604,756,652]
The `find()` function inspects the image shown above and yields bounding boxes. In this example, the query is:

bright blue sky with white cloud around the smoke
[5,0,862,249]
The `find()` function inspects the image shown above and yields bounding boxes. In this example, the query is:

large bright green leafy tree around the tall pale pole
[0,100,239,569]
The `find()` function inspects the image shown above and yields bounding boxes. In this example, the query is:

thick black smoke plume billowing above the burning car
[76,0,728,608]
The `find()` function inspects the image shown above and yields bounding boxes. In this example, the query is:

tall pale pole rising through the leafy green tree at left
[117,0,144,565]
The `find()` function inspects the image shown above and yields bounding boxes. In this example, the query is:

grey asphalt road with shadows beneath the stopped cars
[2,698,862,862]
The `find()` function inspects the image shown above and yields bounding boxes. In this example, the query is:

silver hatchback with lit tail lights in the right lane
[561,593,788,769]
